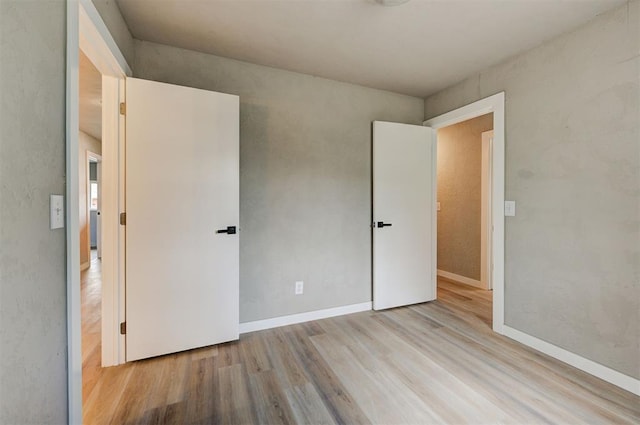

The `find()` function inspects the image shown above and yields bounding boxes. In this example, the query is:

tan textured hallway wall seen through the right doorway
[438,114,493,280]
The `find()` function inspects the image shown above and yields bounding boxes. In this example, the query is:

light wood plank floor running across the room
[83,268,640,424]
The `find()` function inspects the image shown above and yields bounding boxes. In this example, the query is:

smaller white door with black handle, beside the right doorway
[373,121,436,310]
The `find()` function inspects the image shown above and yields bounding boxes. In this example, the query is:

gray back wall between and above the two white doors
[134,41,424,322]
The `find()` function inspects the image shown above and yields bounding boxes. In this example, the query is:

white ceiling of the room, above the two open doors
[118,0,625,97]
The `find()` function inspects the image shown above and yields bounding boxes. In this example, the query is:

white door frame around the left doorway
[66,1,131,423]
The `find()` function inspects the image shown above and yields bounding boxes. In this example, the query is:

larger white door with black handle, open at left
[126,78,239,361]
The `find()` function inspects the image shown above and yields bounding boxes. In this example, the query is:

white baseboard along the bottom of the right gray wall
[503,325,640,395]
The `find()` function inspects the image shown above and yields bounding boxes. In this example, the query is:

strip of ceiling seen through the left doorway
[79,50,102,140]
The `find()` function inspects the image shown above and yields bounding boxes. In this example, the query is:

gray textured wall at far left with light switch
[0,0,67,424]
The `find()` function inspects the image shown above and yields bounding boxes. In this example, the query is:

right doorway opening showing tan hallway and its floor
[436,113,493,326]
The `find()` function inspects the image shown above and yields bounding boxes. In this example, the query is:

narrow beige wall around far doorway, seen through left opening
[78,131,102,268]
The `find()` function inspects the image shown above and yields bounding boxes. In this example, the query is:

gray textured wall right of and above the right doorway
[425,1,640,378]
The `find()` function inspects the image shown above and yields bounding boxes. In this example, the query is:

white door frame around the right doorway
[423,92,505,334]
